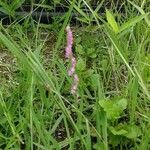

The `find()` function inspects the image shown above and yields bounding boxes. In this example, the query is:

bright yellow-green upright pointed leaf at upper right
[106,9,119,33]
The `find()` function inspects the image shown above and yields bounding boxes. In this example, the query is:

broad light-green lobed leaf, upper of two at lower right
[99,99,127,120]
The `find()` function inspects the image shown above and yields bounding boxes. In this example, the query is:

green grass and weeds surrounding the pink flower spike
[0,0,150,150]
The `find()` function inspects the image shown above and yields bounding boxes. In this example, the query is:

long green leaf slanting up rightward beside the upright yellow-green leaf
[119,14,148,32]
